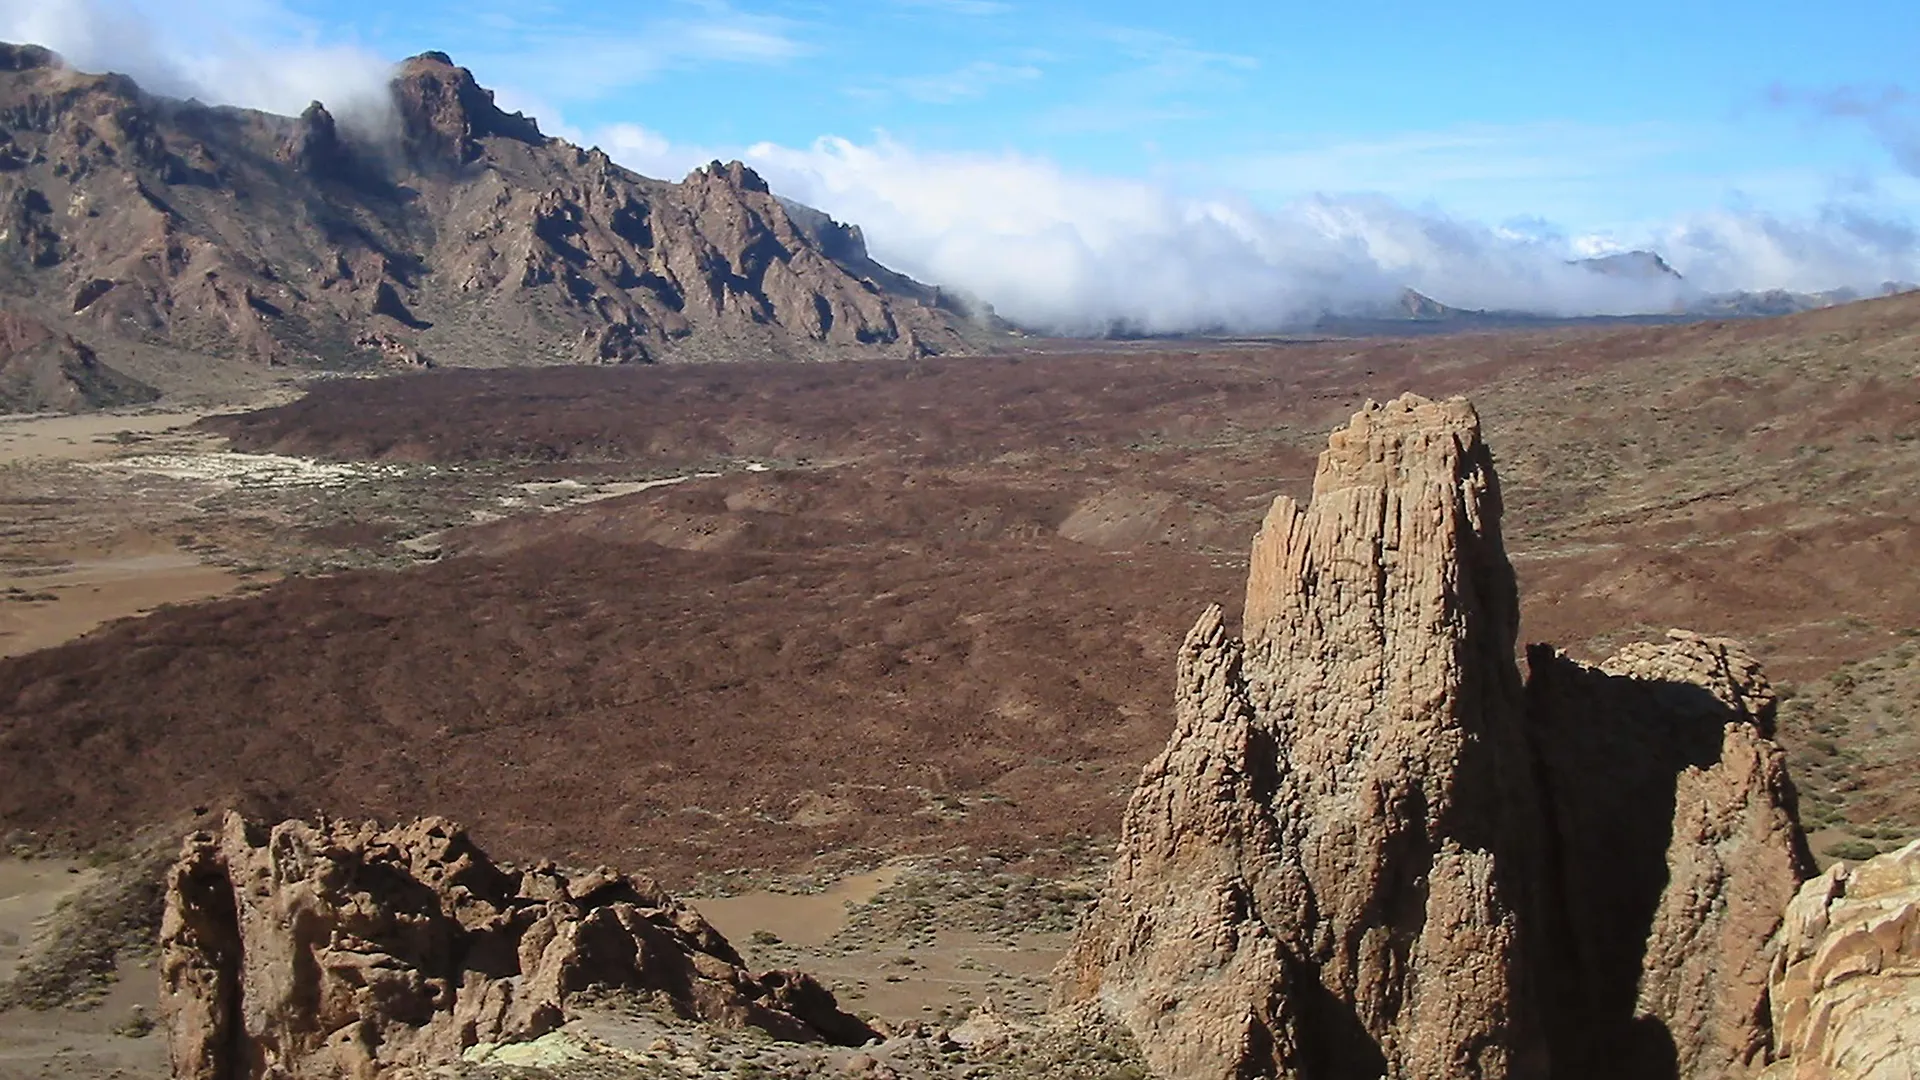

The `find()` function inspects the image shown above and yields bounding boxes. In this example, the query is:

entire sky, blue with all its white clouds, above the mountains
[0,0,1920,321]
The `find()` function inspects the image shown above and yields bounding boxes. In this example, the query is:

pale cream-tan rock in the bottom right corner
[1764,842,1920,1080]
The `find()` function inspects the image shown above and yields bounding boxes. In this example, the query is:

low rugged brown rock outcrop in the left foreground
[161,815,874,1080]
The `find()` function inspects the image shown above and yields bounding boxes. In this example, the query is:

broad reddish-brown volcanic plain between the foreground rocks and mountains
[0,296,1920,1068]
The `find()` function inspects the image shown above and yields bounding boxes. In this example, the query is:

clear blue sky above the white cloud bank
[288,0,1920,229]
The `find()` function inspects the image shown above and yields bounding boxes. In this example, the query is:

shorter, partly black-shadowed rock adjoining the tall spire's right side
[1526,630,1812,1078]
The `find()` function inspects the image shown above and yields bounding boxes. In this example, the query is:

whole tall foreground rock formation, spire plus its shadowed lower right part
[1056,396,1811,1080]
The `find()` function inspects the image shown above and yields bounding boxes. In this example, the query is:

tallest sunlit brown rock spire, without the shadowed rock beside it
[1056,396,1544,1078]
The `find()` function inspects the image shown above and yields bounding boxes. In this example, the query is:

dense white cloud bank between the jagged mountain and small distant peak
[721,138,1712,332]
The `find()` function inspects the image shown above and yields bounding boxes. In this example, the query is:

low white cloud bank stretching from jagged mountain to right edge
[729,138,1920,332]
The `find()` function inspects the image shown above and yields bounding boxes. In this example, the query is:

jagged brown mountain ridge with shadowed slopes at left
[0,46,987,403]
